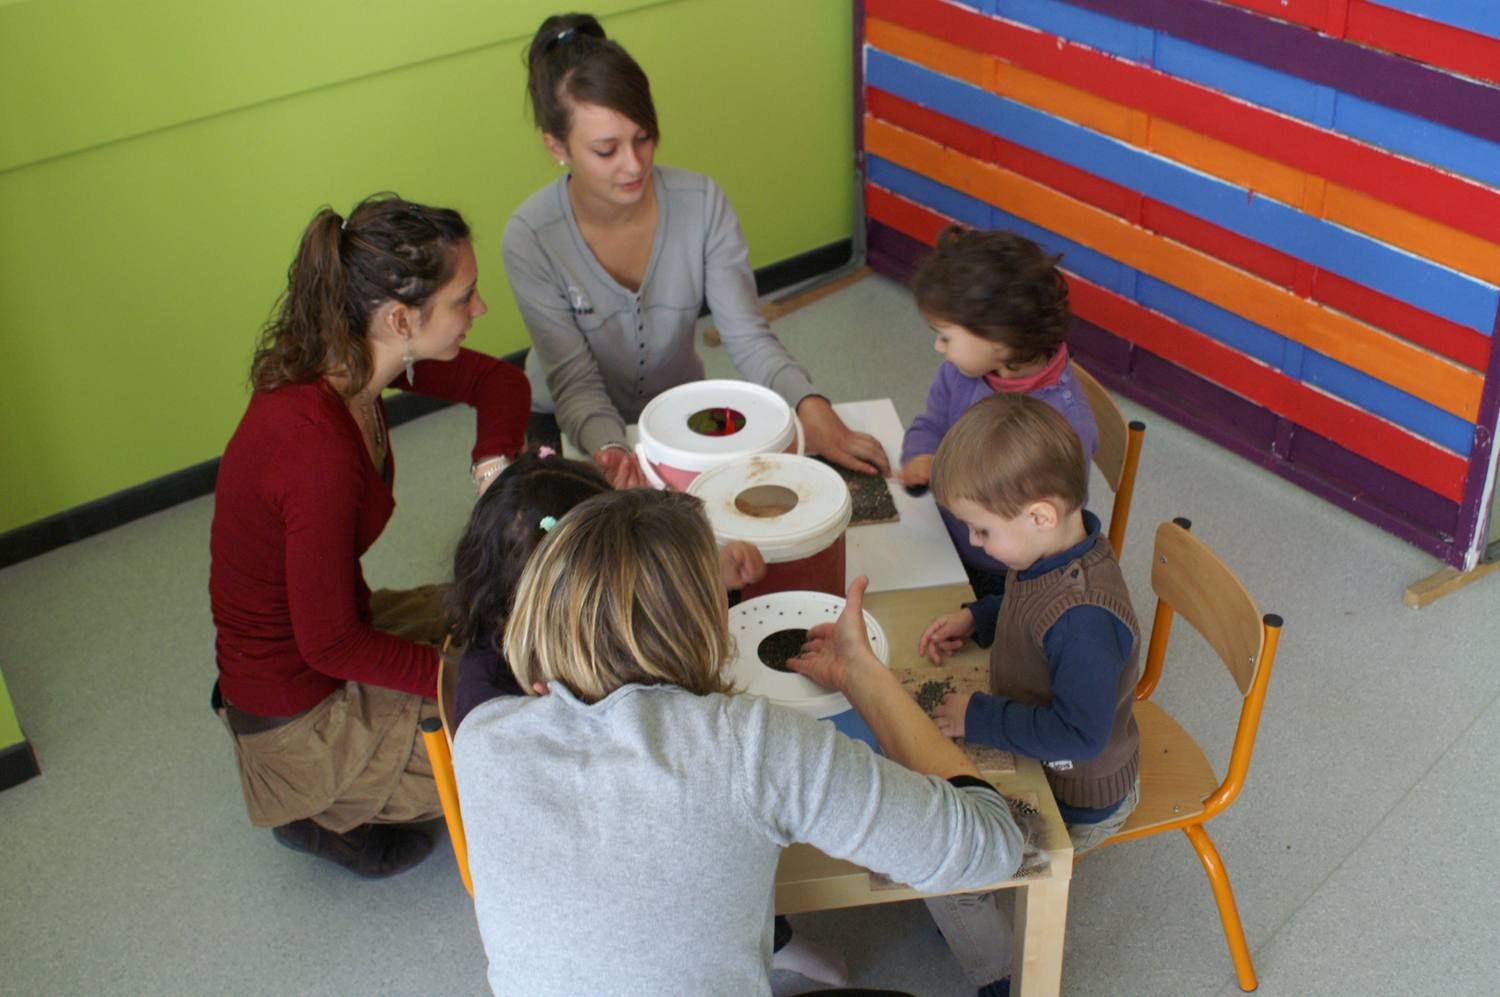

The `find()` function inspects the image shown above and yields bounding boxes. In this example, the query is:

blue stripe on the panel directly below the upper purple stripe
[969,0,1500,187]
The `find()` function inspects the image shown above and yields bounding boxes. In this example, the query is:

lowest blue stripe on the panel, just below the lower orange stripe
[867,167,1475,456]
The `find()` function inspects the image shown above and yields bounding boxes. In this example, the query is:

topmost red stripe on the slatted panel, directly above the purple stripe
[1220,0,1500,82]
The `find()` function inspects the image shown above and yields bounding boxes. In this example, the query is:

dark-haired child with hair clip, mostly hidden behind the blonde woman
[447,447,845,984]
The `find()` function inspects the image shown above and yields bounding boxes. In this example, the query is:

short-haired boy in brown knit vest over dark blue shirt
[918,394,1140,997]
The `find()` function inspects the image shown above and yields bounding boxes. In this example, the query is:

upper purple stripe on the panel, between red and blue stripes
[1067,0,1500,142]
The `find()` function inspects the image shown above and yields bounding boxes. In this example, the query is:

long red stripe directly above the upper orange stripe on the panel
[866,0,1500,243]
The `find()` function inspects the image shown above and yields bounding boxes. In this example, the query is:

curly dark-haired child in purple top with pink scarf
[899,225,1100,597]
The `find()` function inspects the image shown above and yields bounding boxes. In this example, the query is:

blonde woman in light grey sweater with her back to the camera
[453,489,1022,996]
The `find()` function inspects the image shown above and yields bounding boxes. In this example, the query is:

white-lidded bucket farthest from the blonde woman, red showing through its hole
[636,381,804,492]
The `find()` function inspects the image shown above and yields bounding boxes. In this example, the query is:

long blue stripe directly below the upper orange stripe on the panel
[866,49,1500,329]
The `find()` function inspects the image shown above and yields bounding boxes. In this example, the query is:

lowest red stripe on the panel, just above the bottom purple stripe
[864,184,1469,502]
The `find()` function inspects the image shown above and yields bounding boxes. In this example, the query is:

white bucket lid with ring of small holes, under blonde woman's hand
[729,592,891,720]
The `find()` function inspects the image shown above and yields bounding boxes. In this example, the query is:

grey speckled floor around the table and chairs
[0,279,1500,997]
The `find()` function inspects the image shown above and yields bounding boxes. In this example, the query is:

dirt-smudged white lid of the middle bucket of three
[687,453,854,564]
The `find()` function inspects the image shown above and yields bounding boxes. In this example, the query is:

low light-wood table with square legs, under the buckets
[776,585,1073,997]
